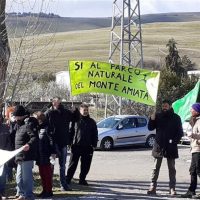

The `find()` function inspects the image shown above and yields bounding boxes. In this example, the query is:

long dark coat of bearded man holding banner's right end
[148,109,183,158]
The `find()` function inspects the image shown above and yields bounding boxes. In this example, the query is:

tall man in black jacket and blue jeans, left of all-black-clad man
[46,97,73,191]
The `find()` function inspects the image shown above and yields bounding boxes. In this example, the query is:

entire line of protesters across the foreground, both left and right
[0,97,200,200]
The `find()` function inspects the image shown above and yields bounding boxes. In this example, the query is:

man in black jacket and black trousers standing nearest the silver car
[66,104,98,185]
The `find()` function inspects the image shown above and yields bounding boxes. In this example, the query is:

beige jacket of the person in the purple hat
[190,116,200,153]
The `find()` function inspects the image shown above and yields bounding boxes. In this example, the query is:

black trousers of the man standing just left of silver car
[67,145,93,182]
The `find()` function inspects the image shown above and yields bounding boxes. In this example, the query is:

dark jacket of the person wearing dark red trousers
[36,122,56,165]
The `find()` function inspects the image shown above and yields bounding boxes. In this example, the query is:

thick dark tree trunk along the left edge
[0,0,10,105]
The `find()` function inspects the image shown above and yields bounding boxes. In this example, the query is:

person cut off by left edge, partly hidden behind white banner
[0,114,11,199]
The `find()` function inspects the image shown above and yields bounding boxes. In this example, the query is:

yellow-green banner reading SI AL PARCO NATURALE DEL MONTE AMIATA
[69,61,160,105]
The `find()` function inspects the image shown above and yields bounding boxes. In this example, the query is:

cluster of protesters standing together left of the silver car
[0,97,98,200]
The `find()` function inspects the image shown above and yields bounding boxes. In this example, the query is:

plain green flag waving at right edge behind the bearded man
[172,81,200,122]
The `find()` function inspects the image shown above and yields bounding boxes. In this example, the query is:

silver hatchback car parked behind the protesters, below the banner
[97,115,155,150]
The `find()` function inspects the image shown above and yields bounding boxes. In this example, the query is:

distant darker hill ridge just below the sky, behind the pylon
[6,12,200,37]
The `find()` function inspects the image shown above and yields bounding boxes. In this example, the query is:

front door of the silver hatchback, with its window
[115,117,137,145]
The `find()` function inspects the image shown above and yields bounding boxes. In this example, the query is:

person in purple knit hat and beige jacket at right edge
[182,103,200,199]
